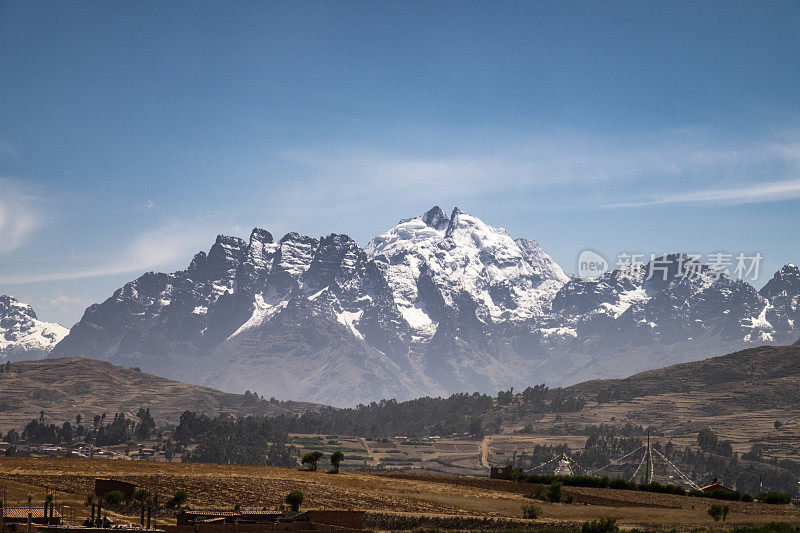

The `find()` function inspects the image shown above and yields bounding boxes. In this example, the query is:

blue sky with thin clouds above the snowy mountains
[0,1,800,325]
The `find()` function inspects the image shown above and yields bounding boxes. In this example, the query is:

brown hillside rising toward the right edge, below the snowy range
[500,346,800,461]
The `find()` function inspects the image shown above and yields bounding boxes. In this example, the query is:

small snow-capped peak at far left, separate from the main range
[0,295,69,363]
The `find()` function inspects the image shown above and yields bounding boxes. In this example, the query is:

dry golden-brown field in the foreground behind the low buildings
[0,458,800,531]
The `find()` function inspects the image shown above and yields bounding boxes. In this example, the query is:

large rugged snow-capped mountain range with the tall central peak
[52,207,800,405]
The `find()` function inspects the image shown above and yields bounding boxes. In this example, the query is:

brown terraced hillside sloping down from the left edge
[0,357,313,431]
